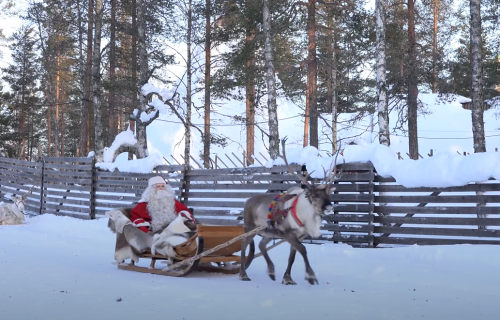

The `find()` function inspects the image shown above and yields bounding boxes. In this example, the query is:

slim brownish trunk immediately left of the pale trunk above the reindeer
[245,24,255,162]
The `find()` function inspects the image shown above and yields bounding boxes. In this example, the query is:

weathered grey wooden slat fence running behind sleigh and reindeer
[0,157,500,247]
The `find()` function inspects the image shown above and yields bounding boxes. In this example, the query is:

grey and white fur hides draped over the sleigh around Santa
[106,209,196,263]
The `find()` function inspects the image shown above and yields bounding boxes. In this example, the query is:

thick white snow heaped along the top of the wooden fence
[97,138,500,188]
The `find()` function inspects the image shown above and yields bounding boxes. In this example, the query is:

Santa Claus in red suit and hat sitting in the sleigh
[130,176,194,233]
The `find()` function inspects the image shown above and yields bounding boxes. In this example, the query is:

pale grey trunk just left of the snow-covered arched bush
[92,0,104,162]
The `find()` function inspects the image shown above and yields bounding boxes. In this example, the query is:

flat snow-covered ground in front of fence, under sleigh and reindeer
[0,215,500,320]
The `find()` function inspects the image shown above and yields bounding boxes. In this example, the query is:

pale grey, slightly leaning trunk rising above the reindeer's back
[262,0,280,160]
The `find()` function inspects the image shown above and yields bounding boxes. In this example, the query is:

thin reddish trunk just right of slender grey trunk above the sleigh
[203,0,212,169]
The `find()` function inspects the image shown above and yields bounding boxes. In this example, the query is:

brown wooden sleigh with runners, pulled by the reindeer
[118,225,255,277]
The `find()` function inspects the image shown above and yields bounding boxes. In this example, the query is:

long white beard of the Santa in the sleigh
[147,186,176,232]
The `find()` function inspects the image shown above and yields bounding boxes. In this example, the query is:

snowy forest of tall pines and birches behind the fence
[0,0,500,168]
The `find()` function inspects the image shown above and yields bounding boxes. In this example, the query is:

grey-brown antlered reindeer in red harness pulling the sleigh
[239,138,340,285]
